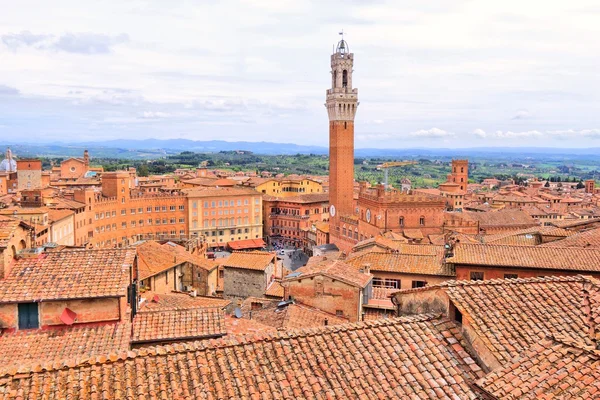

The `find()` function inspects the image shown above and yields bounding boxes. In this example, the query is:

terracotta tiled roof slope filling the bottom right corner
[476,336,600,399]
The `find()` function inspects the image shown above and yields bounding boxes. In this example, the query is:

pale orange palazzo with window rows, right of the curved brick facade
[184,187,263,248]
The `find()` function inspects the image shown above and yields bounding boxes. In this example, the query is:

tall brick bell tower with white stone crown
[325,35,359,243]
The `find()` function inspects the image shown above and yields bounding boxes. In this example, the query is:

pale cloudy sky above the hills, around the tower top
[0,0,600,147]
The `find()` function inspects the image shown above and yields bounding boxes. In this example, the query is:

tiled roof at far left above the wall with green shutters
[0,249,135,303]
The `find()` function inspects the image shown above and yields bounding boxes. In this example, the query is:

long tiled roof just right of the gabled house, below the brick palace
[345,252,454,276]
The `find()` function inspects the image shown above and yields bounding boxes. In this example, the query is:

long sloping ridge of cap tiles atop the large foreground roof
[0,313,443,379]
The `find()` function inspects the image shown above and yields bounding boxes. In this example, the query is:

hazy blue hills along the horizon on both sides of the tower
[0,139,600,159]
